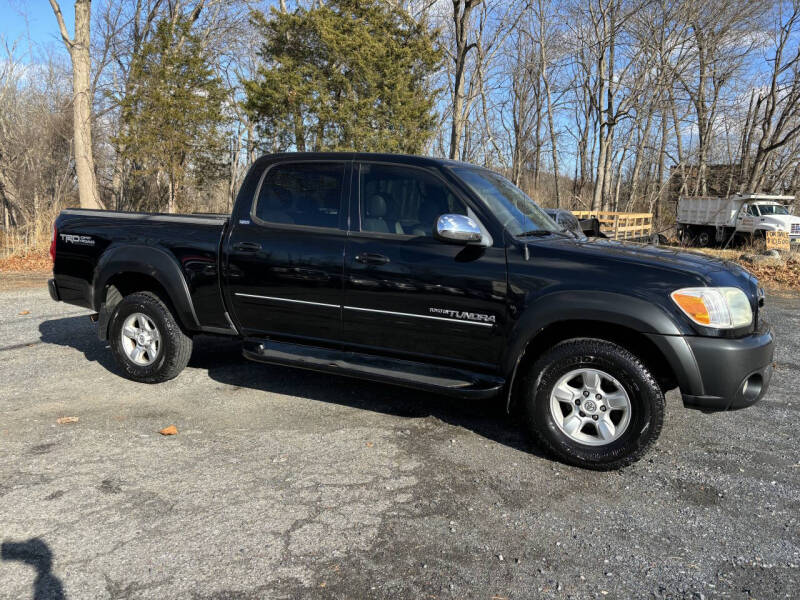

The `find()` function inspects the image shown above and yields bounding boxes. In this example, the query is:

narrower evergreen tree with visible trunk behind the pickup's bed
[116,19,226,212]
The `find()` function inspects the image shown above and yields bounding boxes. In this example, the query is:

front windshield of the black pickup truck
[453,167,561,235]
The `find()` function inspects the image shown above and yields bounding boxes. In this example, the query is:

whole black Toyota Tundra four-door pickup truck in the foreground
[49,153,773,469]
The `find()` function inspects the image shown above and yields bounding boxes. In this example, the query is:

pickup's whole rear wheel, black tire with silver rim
[109,292,192,383]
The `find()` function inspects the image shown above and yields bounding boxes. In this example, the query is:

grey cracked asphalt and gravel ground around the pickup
[0,277,800,600]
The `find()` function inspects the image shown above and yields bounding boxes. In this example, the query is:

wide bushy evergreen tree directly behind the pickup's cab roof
[245,0,442,153]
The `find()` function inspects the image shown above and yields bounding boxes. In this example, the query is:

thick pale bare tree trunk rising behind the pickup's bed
[50,0,104,208]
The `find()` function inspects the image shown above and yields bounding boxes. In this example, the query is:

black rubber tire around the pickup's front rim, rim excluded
[522,338,664,470]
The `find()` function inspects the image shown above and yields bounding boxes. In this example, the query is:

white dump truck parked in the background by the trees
[677,194,800,246]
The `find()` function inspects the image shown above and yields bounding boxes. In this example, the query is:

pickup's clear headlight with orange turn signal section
[670,287,753,329]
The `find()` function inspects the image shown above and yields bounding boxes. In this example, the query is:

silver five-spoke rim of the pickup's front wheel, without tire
[550,369,632,446]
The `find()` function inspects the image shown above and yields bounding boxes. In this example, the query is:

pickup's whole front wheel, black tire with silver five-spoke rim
[523,338,664,470]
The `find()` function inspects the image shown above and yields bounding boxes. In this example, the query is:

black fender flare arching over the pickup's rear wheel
[92,245,200,331]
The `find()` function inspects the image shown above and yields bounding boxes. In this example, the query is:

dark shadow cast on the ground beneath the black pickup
[39,316,541,456]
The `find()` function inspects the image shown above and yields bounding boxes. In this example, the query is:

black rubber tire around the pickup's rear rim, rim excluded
[108,292,192,383]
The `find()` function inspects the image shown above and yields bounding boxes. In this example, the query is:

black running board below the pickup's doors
[242,339,505,399]
